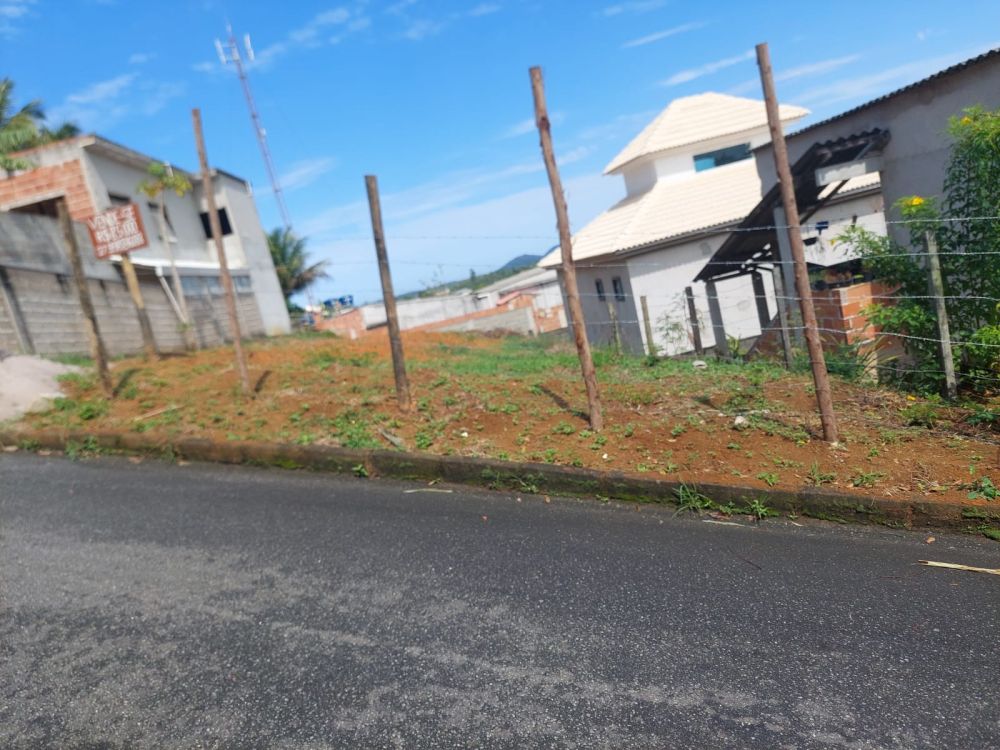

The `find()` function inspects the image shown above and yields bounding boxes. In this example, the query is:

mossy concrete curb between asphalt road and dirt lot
[0,428,1000,533]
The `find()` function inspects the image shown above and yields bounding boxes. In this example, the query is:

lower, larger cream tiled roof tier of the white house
[538,159,760,268]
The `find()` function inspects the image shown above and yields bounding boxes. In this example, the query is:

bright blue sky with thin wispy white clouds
[0,0,1000,299]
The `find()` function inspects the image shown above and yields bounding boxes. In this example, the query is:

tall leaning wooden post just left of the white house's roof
[530,65,604,432]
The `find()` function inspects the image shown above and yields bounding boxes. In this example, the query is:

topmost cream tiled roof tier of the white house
[604,92,809,174]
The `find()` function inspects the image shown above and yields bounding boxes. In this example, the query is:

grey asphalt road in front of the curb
[0,454,1000,750]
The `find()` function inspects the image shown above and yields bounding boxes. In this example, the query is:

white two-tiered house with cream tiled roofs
[539,93,880,354]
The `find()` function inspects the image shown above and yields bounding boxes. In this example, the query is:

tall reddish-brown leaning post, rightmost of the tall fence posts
[757,43,837,443]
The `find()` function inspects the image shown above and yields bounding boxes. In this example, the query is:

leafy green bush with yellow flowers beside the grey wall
[841,107,1000,390]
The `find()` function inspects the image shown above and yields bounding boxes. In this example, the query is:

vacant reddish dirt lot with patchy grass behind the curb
[13,334,1000,516]
